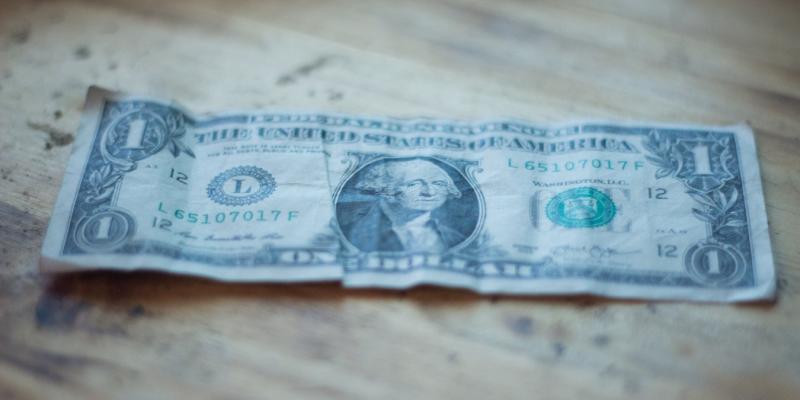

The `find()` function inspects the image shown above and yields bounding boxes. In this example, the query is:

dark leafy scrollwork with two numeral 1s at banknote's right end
[643,130,752,286]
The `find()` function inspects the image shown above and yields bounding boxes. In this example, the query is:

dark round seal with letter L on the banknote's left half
[207,165,276,206]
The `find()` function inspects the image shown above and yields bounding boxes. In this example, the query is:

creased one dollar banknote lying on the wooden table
[42,88,775,301]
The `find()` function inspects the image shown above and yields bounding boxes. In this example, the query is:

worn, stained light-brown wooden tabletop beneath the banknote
[0,0,800,399]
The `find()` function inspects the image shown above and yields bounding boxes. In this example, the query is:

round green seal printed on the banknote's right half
[545,187,617,228]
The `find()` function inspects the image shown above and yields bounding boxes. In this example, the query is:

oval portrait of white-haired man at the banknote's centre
[336,157,479,253]
